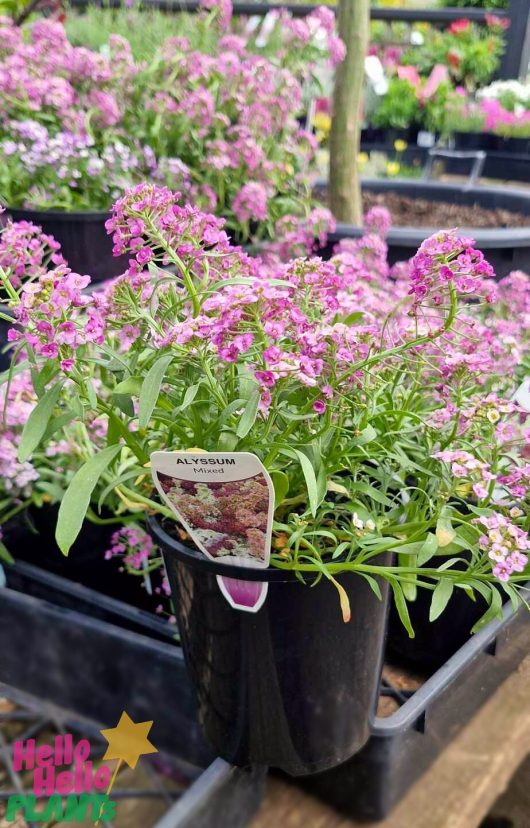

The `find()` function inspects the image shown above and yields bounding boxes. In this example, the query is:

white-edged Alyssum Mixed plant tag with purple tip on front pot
[151,450,274,612]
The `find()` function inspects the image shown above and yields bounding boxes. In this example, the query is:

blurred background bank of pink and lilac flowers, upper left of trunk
[0,13,343,241]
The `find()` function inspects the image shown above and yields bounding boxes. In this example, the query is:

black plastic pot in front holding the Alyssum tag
[150,520,388,776]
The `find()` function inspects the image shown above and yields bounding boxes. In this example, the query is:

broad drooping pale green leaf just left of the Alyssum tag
[55,446,121,555]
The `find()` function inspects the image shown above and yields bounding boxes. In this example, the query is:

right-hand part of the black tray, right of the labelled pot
[300,605,530,820]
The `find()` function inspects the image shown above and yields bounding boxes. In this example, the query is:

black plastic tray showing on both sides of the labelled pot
[4,563,530,828]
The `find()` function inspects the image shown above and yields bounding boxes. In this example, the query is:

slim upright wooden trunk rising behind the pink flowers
[329,0,370,224]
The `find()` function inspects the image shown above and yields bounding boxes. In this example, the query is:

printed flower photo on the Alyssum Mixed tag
[158,473,269,564]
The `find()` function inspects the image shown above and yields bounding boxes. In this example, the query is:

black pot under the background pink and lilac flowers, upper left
[8,207,129,282]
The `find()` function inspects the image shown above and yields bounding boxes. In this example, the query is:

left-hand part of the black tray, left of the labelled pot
[0,563,215,768]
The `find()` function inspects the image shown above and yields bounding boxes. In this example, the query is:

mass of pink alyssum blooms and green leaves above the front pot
[4,185,530,626]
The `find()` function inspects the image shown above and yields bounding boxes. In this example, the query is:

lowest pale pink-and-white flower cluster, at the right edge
[473,513,530,581]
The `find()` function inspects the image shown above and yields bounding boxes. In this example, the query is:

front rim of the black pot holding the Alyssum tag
[147,517,346,587]
